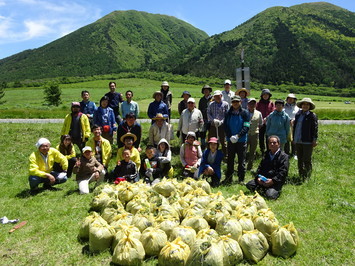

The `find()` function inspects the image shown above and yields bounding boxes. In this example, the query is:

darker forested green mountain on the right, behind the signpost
[161,2,355,87]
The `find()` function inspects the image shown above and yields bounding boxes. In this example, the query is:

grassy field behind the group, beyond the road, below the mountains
[0,78,355,119]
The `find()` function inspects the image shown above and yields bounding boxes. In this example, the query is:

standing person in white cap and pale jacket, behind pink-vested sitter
[177,97,203,140]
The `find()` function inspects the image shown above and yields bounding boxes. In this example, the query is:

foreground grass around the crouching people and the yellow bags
[0,124,355,265]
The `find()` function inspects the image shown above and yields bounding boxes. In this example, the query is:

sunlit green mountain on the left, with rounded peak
[0,10,208,81]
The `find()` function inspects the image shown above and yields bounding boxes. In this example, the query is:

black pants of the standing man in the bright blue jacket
[226,141,247,183]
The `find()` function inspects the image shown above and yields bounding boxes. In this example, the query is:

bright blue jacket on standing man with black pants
[224,107,250,142]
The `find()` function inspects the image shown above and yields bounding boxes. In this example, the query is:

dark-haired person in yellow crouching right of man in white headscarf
[53,135,76,178]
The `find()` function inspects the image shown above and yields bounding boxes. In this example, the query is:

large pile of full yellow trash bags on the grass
[79,178,299,266]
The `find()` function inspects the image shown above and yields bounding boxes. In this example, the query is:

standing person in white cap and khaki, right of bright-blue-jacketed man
[247,98,263,170]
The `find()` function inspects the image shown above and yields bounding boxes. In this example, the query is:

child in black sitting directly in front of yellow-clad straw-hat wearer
[113,149,139,184]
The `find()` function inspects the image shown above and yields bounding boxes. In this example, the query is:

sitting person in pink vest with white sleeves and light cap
[180,132,202,179]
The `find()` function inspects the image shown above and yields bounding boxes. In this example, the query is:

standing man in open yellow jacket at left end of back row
[61,102,91,150]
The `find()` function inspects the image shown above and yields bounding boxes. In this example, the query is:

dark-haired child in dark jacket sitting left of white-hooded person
[140,145,163,186]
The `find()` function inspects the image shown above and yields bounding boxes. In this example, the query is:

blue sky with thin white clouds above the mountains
[0,0,355,59]
